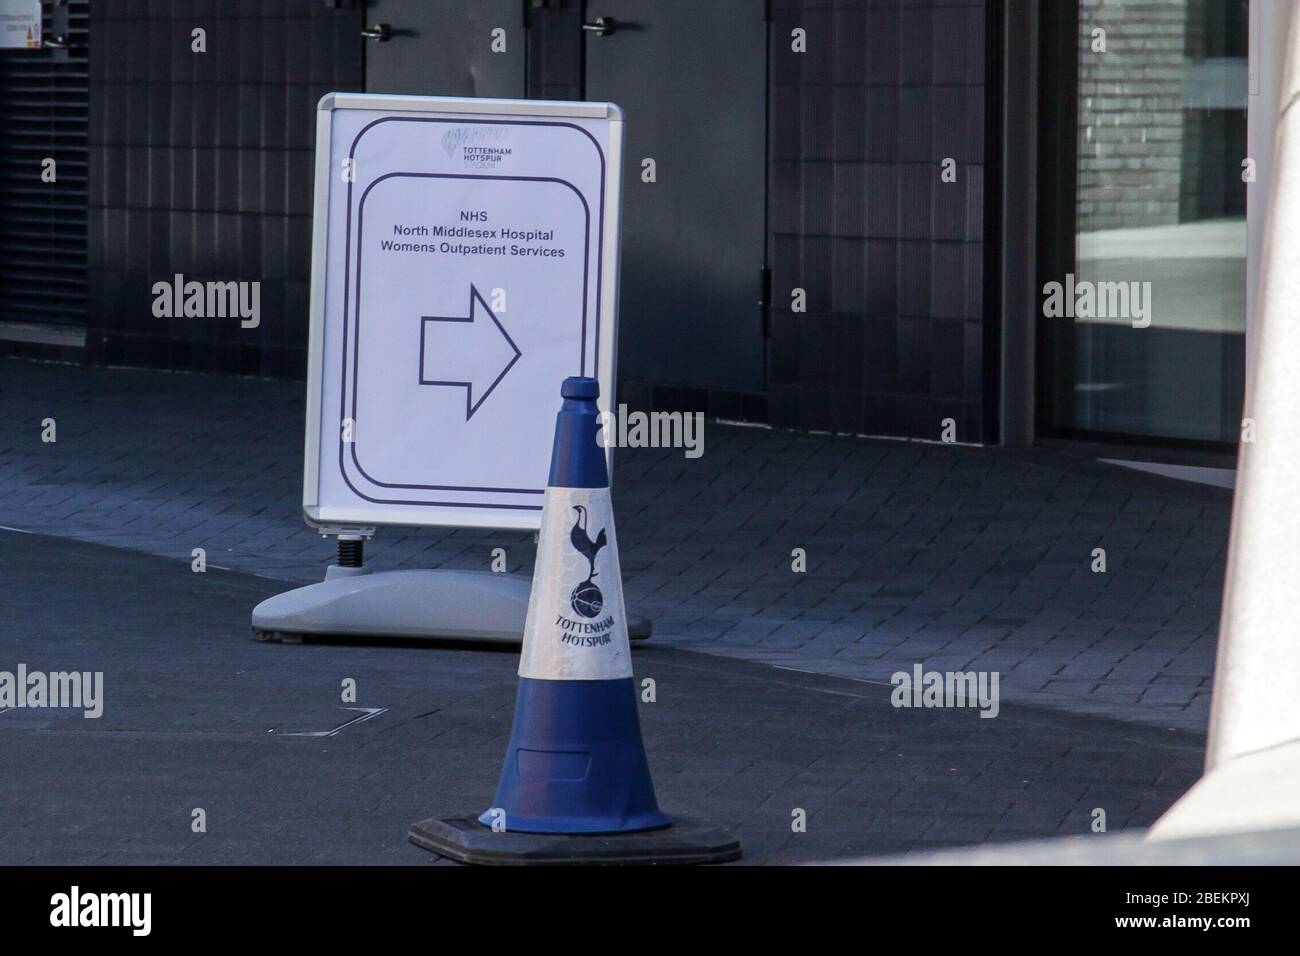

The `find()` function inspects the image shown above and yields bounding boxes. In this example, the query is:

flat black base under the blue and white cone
[411,817,740,866]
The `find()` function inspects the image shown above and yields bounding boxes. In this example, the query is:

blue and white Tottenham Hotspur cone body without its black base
[478,378,670,834]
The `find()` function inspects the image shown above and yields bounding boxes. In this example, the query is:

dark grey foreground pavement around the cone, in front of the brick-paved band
[0,532,1205,865]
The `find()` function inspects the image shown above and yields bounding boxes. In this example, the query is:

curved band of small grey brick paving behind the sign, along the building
[0,362,1231,731]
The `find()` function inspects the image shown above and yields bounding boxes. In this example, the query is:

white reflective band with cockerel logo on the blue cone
[519,488,632,680]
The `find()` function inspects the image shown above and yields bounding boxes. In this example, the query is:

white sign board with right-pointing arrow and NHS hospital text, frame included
[303,94,623,529]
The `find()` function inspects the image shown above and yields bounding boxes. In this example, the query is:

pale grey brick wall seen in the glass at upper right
[1078,0,1188,232]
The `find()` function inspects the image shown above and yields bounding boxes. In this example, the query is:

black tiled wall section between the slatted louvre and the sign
[87,0,363,377]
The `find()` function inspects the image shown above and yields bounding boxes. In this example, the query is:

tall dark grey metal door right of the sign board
[585,0,767,392]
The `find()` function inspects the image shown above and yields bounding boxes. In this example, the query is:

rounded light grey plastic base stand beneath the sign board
[245,564,651,644]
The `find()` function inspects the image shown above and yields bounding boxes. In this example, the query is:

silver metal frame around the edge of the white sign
[303,92,623,533]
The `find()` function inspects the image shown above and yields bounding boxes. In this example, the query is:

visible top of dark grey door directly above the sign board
[365,0,528,96]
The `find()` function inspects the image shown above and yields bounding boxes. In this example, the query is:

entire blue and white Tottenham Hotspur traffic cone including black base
[411,377,741,864]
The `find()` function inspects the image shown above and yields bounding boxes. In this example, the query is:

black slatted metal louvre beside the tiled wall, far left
[0,0,90,338]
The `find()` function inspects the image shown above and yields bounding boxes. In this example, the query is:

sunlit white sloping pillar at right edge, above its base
[1206,0,1300,770]
